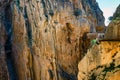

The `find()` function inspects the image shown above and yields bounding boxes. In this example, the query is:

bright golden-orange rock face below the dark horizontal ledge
[78,41,120,80]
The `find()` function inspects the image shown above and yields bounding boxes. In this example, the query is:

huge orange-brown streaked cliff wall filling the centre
[0,0,104,80]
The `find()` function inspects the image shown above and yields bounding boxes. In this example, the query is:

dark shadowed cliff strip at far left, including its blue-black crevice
[0,0,16,80]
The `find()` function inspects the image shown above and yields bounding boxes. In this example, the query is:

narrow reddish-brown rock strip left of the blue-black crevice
[0,8,9,80]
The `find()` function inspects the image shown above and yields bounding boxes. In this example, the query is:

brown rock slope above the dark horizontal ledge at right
[105,5,120,40]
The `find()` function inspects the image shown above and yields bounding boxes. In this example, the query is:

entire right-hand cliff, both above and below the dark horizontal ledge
[78,6,120,80]
